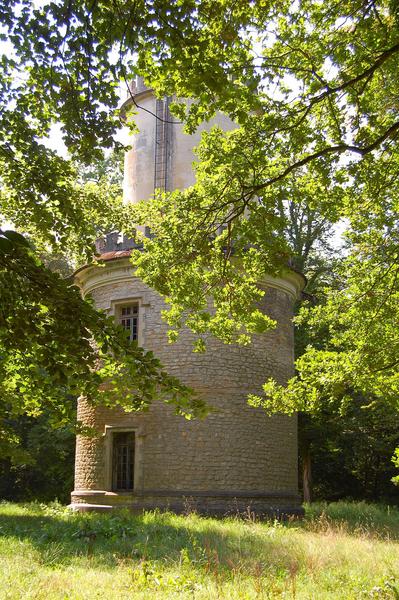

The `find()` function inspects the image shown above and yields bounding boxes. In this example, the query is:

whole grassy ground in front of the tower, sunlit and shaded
[0,502,399,600]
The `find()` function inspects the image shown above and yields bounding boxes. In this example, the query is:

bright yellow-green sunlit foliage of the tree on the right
[132,2,399,422]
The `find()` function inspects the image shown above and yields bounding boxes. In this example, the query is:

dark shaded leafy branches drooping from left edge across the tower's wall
[0,231,204,456]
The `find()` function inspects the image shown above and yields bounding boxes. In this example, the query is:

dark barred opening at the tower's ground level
[112,431,135,492]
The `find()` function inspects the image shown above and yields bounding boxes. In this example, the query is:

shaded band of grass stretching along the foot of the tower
[0,503,399,571]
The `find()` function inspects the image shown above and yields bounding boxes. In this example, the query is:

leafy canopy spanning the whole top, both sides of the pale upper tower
[0,0,399,458]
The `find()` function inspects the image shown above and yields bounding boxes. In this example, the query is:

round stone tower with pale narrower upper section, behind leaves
[72,81,303,514]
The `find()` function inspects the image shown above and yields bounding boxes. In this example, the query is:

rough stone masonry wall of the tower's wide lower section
[75,260,297,502]
